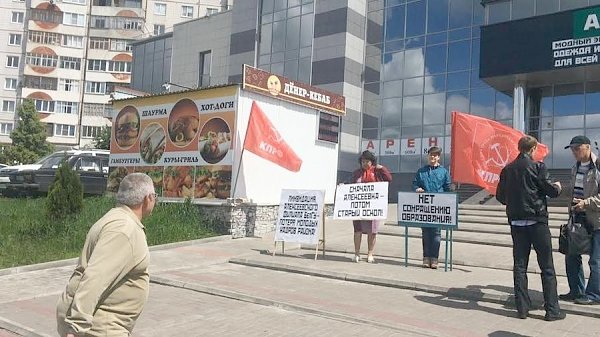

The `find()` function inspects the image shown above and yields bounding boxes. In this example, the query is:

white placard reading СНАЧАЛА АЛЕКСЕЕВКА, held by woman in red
[333,181,388,220]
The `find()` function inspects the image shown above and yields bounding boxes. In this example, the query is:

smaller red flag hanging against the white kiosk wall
[244,102,302,172]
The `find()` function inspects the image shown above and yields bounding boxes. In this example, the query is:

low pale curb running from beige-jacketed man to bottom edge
[150,277,438,336]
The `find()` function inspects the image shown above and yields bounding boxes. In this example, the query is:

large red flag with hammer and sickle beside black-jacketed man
[450,111,548,194]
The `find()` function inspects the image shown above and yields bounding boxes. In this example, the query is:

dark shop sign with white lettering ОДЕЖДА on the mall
[479,7,600,80]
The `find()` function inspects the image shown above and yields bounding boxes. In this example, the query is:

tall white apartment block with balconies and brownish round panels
[0,0,231,146]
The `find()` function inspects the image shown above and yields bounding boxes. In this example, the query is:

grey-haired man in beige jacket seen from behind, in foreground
[56,173,156,337]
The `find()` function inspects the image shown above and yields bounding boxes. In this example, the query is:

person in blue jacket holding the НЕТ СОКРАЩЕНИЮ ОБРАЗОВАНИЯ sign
[412,146,453,269]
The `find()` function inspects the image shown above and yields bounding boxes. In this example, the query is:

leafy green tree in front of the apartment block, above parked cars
[4,99,54,164]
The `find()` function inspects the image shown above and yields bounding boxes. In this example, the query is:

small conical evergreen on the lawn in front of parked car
[46,160,83,219]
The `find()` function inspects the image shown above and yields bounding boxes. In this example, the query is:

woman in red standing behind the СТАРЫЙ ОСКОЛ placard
[348,151,392,263]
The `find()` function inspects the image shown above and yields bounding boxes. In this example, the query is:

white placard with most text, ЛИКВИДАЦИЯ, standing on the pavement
[275,190,325,244]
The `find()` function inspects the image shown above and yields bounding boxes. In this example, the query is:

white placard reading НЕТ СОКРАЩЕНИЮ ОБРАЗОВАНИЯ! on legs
[398,192,458,227]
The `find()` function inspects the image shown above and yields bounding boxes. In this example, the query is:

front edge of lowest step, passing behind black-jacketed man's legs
[229,258,600,317]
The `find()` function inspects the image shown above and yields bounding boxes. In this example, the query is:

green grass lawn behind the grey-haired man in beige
[0,197,222,269]
